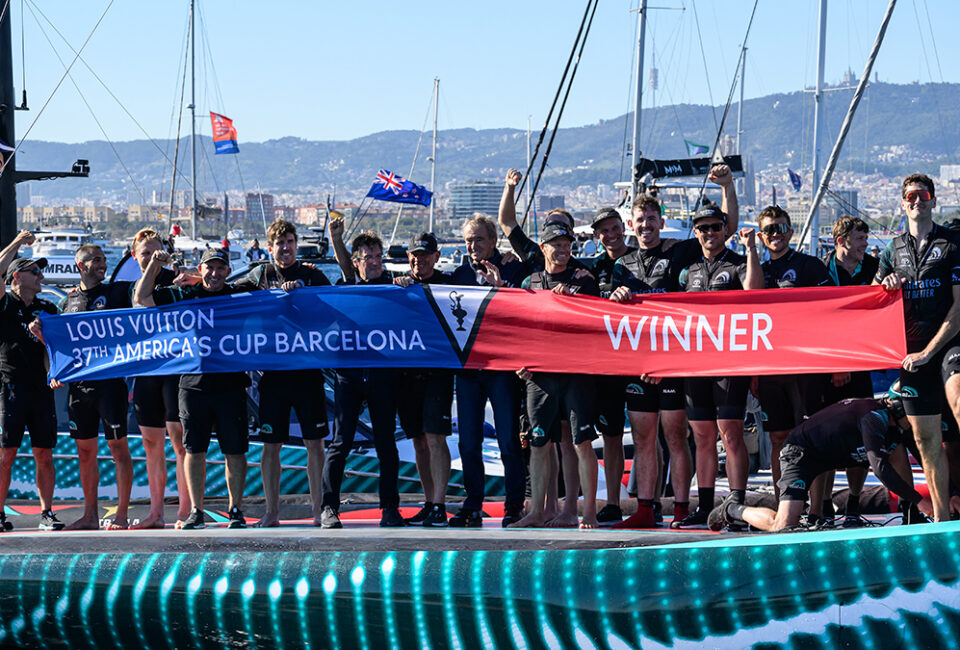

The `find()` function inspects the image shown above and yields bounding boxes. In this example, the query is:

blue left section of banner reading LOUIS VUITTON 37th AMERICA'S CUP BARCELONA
[42,285,461,382]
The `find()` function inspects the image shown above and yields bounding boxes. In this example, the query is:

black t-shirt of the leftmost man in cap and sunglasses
[0,290,58,387]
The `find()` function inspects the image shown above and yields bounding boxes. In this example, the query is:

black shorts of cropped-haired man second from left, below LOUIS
[67,379,130,440]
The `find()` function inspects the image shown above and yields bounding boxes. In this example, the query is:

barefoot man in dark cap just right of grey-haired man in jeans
[511,223,600,528]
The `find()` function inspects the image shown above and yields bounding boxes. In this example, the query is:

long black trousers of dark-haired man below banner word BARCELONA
[322,368,400,510]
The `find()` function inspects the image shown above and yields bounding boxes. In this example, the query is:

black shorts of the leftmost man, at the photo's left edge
[0,384,57,449]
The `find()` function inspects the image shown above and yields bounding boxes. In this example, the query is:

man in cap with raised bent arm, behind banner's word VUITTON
[134,248,250,530]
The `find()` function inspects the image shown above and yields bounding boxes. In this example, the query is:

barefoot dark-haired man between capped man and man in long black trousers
[236,219,330,528]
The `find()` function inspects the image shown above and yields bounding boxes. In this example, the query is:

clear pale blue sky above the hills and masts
[7,0,960,143]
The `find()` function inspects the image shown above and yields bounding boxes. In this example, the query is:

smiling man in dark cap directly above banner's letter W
[584,207,636,524]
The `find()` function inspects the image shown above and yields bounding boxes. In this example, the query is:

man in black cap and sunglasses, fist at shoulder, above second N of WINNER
[676,205,763,527]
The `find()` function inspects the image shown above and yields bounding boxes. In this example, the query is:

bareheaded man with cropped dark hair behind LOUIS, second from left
[60,244,133,530]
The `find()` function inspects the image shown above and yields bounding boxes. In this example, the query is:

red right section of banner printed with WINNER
[466,287,906,377]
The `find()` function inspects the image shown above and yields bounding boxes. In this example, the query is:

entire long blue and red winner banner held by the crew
[41,285,906,381]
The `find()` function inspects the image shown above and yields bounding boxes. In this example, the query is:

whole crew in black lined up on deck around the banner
[0,165,960,530]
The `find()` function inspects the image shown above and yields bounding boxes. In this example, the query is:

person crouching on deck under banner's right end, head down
[707,391,933,531]
